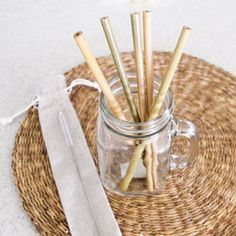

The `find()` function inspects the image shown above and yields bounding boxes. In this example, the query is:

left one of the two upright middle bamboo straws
[131,12,146,121]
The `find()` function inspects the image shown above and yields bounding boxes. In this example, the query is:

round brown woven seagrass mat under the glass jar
[12,52,236,236]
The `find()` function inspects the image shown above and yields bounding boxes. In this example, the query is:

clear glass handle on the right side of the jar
[169,118,199,170]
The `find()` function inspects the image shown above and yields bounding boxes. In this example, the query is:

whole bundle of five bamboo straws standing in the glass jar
[74,11,191,192]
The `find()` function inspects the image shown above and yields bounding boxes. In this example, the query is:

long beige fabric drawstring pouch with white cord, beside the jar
[0,76,121,236]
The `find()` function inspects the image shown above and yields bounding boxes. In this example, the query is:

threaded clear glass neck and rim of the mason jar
[100,73,173,139]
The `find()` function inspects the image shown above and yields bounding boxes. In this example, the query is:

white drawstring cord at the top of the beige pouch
[0,79,101,126]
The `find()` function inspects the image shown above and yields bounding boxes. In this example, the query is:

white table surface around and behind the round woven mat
[0,0,236,236]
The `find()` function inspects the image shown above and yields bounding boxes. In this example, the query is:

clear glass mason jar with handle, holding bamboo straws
[96,74,198,195]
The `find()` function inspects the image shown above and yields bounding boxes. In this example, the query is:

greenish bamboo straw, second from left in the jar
[100,17,140,122]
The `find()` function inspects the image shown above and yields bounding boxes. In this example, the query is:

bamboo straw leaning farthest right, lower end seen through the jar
[119,26,191,192]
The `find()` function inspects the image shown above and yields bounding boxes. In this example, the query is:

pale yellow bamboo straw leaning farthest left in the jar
[74,31,126,120]
